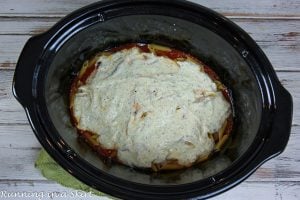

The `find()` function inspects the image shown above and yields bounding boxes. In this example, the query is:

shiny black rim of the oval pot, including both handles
[13,0,292,199]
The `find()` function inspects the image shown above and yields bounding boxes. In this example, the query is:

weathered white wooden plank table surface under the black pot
[0,0,300,200]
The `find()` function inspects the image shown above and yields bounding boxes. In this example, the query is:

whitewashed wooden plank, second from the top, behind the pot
[0,18,300,71]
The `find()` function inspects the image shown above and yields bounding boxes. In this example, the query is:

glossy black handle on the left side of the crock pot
[12,35,47,107]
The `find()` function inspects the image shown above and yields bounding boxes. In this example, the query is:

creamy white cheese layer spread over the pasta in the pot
[73,47,231,167]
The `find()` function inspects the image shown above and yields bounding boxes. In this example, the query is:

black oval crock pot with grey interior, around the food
[13,0,292,199]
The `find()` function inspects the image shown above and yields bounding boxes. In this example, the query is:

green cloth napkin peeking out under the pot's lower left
[35,149,106,196]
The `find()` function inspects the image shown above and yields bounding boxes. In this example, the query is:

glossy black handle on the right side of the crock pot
[262,83,293,161]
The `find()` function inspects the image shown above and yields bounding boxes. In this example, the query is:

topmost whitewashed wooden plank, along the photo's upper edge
[0,0,300,17]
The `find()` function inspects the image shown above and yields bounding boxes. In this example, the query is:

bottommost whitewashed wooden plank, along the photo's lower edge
[0,181,300,200]
